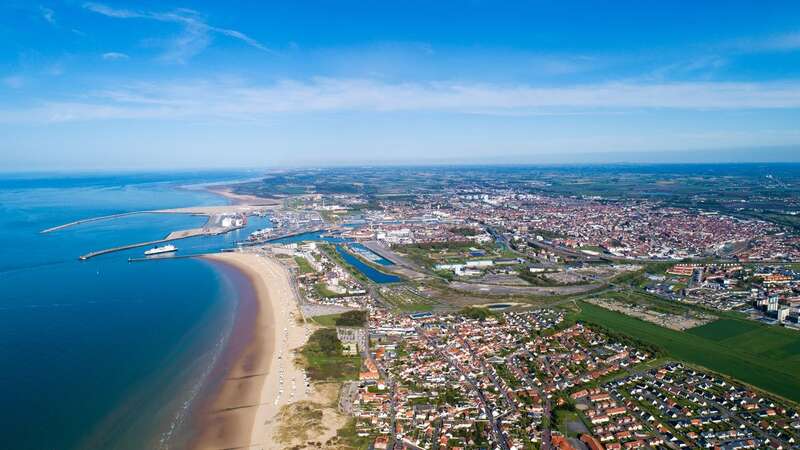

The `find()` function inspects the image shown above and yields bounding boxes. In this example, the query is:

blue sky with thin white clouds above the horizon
[0,0,800,171]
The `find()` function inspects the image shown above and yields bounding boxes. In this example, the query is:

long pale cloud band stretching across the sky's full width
[0,78,800,122]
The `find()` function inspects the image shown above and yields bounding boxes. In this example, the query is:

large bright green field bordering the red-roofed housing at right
[577,302,800,402]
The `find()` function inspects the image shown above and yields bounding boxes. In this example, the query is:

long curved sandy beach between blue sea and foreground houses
[194,253,313,449]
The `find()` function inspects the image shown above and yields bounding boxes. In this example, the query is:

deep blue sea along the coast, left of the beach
[0,171,269,450]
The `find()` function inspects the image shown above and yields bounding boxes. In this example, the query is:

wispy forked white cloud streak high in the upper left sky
[83,2,271,63]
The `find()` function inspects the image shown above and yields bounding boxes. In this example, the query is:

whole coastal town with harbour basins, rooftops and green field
[228,167,800,450]
